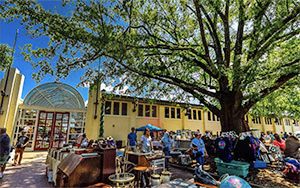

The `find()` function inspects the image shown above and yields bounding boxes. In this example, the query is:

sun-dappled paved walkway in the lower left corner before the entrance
[0,152,53,188]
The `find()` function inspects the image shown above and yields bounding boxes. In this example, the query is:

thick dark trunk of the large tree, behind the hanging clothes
[220,93,250,133]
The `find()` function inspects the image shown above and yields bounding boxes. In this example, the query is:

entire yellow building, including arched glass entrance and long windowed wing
[0,68,300,150]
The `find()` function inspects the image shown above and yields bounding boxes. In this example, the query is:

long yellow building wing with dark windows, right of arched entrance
[86,87,300,141]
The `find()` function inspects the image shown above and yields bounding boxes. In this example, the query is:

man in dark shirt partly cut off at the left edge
[0,128,10,179]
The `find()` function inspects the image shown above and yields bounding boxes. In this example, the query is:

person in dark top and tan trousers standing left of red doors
[13,131,29,166]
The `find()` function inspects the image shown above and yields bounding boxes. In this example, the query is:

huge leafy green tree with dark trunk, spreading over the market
[0,0,300,132]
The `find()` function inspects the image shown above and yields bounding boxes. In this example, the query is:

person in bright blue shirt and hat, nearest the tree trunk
[191,132,207,165]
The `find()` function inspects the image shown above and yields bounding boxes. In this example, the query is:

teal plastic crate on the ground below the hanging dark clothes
[215,158,250,177]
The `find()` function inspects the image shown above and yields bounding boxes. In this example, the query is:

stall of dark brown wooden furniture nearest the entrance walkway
[46,137,116,187]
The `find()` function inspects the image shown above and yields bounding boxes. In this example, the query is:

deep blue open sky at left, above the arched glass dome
[0,0,88,101]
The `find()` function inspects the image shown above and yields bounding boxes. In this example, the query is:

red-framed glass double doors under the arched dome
[34,111,70,150]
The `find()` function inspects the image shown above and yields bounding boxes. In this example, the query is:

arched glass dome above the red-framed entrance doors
[24,82,85,109]
